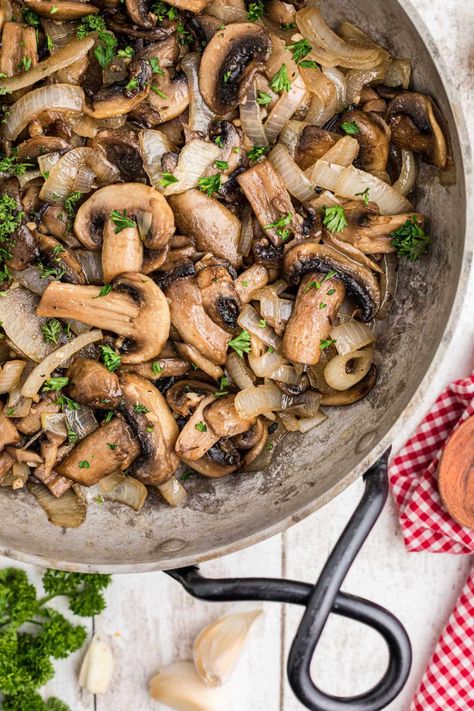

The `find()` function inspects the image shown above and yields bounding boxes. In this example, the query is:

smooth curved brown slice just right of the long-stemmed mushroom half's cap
[165,279,230,365]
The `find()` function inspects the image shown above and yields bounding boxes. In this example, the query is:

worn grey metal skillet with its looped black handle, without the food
[0,0,474,711]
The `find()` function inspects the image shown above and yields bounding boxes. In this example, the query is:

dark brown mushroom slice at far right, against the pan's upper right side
[386,91,448,168]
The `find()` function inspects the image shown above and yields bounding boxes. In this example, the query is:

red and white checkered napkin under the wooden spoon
[389,373,474,711]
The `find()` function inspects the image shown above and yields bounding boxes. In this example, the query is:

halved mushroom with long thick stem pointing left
[37,272,170,363]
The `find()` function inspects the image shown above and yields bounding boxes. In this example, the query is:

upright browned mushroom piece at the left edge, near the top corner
[0,22,38,77]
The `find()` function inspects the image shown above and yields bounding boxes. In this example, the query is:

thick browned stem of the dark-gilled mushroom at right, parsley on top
[283,272,345,365]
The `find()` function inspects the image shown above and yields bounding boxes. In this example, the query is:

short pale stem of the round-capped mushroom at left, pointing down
[102,219,143,284]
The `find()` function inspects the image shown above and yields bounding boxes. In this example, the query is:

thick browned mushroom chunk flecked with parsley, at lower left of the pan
[56,417,140,486]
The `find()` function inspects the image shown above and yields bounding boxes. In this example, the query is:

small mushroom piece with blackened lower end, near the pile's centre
[196,257,241,330]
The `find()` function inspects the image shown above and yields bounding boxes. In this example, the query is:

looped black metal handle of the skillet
[166,452,411,711]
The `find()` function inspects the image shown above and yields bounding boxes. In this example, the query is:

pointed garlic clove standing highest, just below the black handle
[193,610,262,686]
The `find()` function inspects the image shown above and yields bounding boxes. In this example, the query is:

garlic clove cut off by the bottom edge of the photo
[149,662,230,711]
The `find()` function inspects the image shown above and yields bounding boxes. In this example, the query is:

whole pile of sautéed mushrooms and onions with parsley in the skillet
[0,0,446,527]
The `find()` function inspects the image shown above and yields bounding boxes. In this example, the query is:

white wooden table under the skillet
[4,0,474,711]
